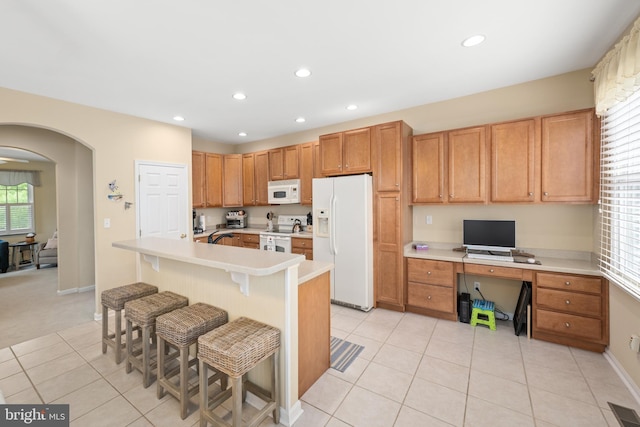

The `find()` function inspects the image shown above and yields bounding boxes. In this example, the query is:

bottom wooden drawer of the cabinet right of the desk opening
[534,309,603,341]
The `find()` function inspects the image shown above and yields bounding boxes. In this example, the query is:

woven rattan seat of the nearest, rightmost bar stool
[198,317,280,377]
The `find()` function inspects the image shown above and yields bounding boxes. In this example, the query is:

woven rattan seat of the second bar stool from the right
[156,302,228,347]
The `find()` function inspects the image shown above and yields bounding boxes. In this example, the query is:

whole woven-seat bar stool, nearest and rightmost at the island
[198,317,280,427]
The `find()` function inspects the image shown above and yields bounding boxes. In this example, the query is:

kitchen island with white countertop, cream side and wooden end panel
[113,237,333,425]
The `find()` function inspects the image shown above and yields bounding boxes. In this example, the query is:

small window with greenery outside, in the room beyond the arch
[0,183,34,235]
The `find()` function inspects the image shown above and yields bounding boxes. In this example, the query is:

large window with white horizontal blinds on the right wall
[600,91,640,299]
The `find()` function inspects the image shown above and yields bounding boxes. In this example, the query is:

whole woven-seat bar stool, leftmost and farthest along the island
[100,282,158,365]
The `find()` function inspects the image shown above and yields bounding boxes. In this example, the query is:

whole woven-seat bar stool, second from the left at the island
[124,291,189,388]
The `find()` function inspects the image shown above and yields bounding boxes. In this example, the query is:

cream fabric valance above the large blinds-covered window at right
[591,18,640,116]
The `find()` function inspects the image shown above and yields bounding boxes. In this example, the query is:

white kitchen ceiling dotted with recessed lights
[0,0,640,152]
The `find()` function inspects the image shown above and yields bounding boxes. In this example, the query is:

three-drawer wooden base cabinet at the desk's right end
[532,272,609,352]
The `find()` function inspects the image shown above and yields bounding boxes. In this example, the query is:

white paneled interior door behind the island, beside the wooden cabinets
[136,161,191,239]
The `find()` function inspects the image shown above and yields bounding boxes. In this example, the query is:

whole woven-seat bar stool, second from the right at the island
[156,302,228,420]
